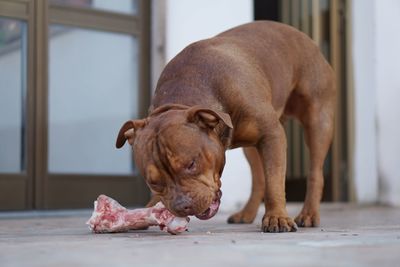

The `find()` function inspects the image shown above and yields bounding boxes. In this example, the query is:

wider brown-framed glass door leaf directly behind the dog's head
[37,0,149,208]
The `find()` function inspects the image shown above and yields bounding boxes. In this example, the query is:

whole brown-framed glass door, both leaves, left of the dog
[0,0,150,210]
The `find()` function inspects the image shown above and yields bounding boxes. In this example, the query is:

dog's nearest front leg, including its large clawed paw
[258,120,297,233]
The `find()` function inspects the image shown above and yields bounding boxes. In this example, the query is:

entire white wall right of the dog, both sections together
[352,0,400,205]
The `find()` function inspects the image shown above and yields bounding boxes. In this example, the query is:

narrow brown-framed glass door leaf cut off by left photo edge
[0,1,33,209]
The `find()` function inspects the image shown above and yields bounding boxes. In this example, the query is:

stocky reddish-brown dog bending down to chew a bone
[116,21,336,232]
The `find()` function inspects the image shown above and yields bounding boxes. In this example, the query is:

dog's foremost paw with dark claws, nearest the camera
[261,214,297,233]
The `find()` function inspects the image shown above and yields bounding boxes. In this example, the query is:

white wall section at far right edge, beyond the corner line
[375,0,400,206]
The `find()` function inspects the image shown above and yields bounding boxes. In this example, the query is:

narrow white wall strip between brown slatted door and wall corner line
[350,0,378,203]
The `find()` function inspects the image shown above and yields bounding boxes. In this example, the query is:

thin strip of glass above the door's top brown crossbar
[50,0,138,15]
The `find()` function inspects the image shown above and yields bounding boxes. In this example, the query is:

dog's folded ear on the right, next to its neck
[188,106,233,129]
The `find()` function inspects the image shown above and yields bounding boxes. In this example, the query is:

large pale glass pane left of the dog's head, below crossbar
[48,25,138,174]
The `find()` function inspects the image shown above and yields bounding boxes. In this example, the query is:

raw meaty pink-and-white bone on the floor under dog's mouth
[86,195,189,234]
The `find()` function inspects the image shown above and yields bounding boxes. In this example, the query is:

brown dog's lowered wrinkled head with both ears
[116,106,233,219]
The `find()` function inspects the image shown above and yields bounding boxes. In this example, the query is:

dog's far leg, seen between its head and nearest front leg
[228,147,265,223]
